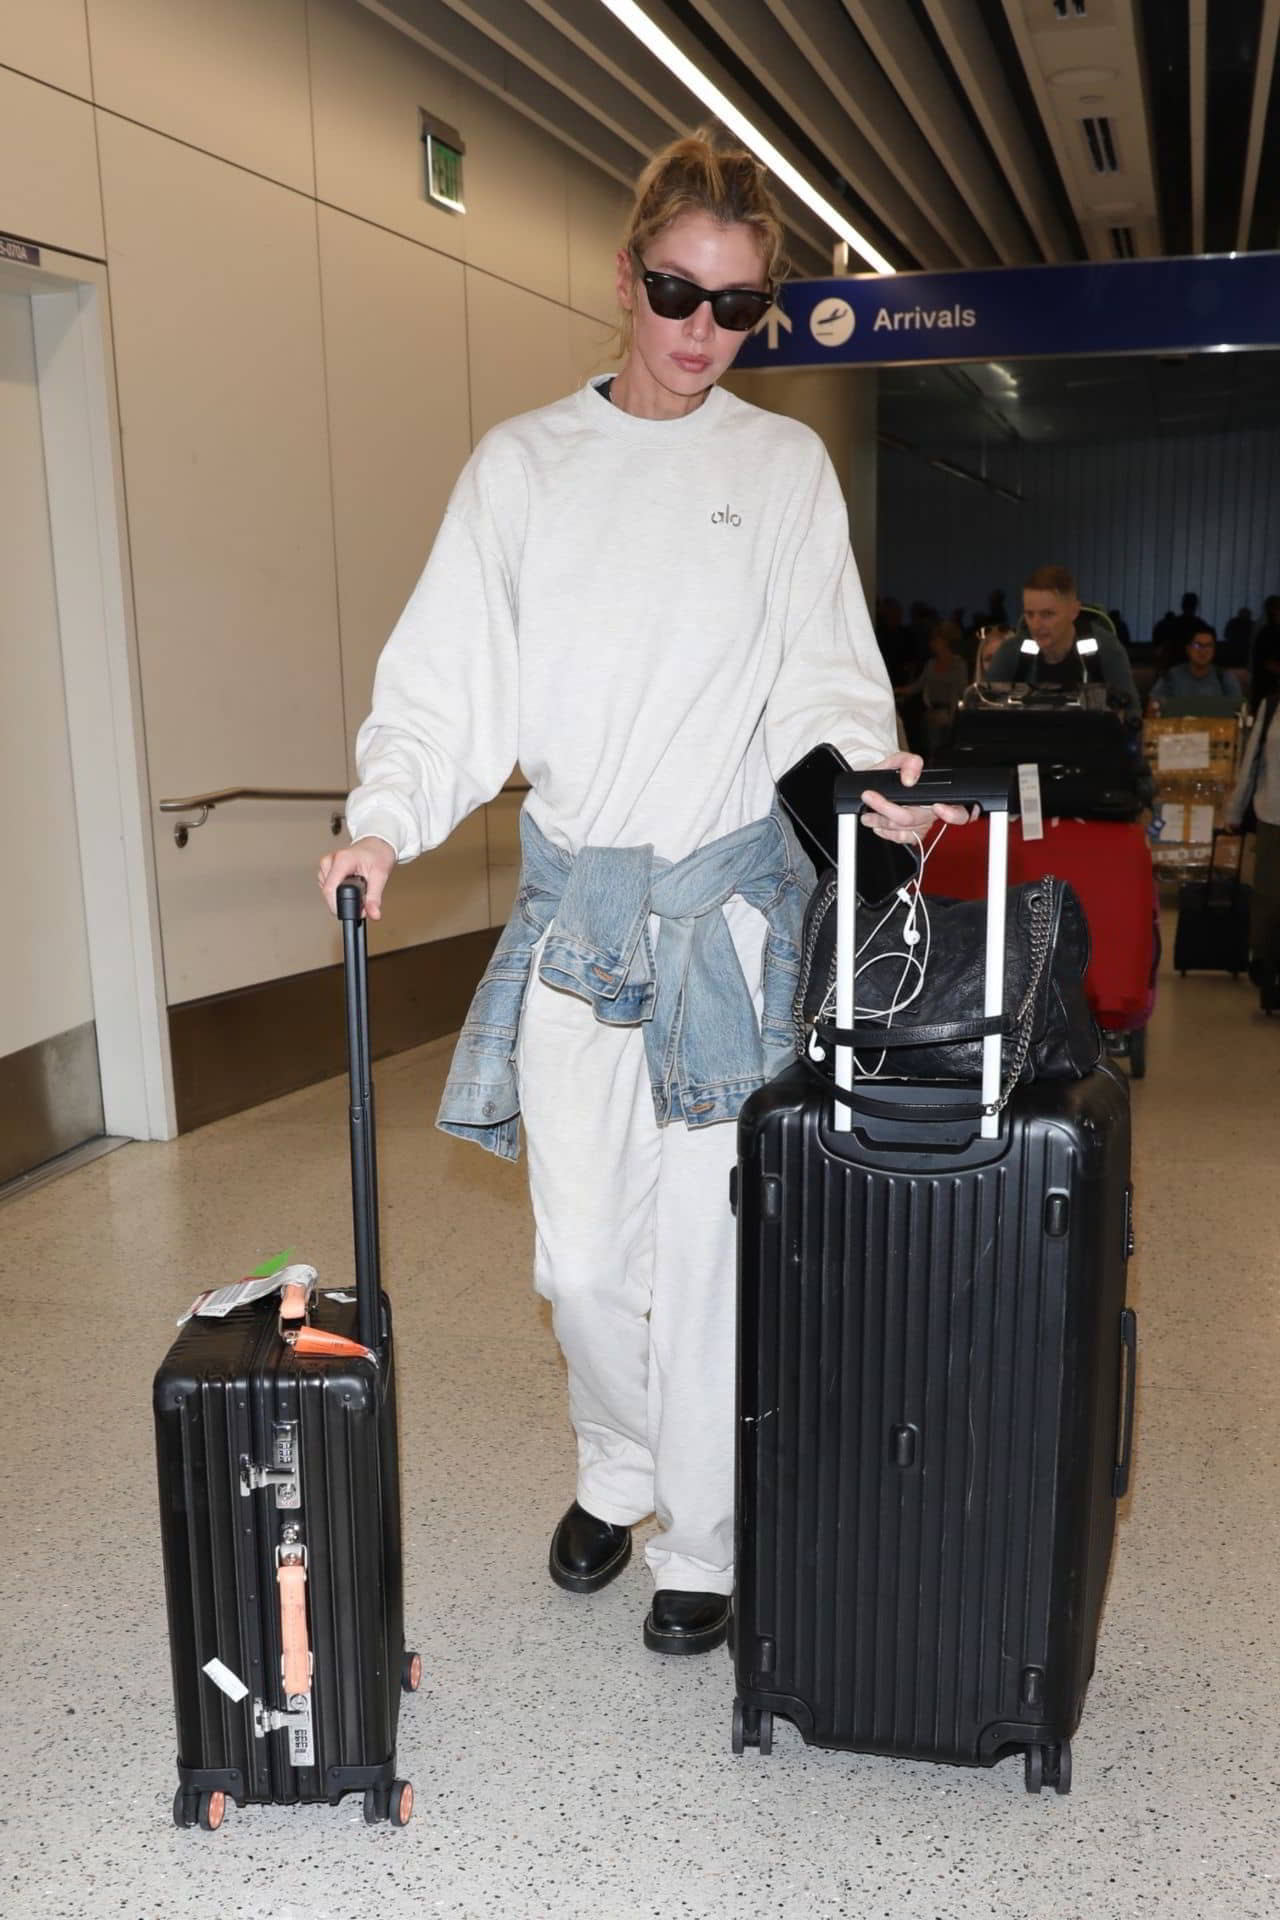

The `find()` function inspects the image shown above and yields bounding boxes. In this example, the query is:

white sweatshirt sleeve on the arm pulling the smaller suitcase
[347,457,518,860]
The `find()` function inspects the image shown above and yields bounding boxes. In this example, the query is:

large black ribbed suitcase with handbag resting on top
[733,774,1136,1793]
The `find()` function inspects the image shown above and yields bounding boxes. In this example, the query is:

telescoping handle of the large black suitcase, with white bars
[835,766,1011,1140]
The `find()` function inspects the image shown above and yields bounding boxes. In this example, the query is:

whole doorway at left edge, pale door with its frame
[0,252,175,1192]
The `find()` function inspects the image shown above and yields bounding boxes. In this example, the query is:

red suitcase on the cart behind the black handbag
[925,820,1159,1079]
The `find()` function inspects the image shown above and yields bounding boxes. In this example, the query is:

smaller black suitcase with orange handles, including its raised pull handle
[154,883,420,1828]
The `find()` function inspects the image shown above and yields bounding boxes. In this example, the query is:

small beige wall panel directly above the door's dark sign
[0,67,104,259]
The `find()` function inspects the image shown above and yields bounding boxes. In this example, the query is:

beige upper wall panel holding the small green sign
[309,0,472,259]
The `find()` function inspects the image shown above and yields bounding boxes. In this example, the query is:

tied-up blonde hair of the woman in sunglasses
[616,127,787,359]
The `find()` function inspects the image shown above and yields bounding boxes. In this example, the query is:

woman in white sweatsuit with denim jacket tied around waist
[320,134,958,1653]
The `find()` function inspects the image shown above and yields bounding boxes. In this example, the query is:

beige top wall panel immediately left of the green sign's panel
[88,0,315,194]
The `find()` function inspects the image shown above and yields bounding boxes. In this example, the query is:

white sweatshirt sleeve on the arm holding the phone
[764,453,898,780]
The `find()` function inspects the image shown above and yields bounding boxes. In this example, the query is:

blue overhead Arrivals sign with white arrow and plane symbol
[737,253,1280,369]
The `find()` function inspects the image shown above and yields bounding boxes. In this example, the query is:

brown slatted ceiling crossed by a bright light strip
[351,0,1280,275]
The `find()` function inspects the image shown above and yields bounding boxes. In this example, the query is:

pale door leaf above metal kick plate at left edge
[0,292,94,1058]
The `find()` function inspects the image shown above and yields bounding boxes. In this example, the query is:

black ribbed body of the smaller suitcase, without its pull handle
[154,1294,405,1805]
